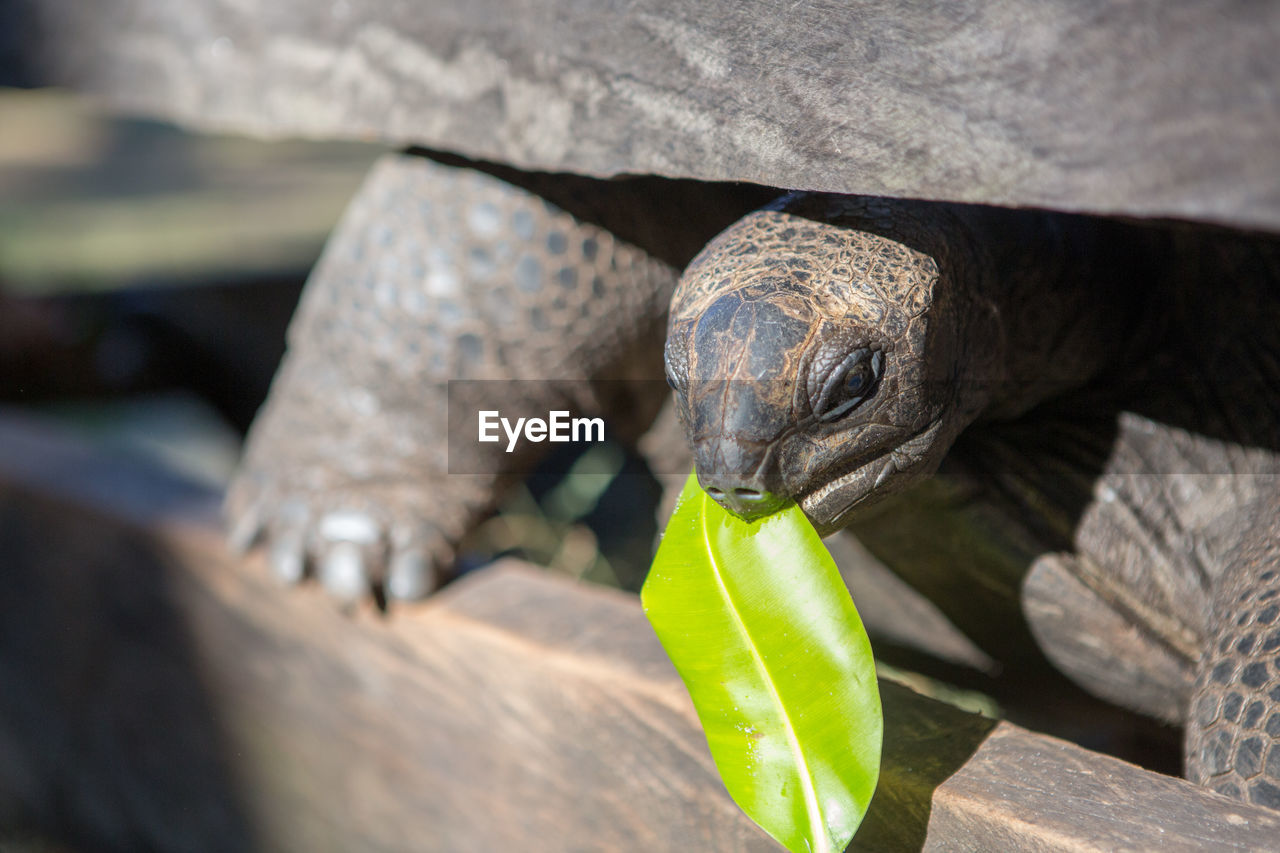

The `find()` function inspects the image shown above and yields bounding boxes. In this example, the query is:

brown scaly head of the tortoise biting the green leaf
[666,195,972,535]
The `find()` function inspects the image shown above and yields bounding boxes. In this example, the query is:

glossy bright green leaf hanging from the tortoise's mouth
[640,475,883,852]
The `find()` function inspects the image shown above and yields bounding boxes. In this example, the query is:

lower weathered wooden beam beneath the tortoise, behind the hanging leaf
[0,409,1280,850]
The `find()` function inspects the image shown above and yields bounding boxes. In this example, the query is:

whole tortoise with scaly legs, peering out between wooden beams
[228,151,1280,807]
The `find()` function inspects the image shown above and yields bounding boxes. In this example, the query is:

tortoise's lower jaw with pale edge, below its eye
[796,420,942,537]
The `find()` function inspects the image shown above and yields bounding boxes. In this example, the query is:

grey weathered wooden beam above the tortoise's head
[23,0,1280,229]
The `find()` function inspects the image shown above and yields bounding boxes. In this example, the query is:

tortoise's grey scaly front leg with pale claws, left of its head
[227,155,676,599]
